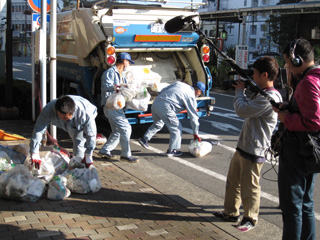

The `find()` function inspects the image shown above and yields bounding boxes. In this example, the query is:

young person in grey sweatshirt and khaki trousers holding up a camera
[214,57,282,232]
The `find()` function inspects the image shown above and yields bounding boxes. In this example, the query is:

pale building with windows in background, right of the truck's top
[198,0,279,61]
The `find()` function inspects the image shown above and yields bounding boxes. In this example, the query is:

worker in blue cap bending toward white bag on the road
[139,82,206,157]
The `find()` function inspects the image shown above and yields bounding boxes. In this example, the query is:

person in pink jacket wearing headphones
[274,38,320,240]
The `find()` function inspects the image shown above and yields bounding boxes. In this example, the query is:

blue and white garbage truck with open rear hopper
[52,0,215,124]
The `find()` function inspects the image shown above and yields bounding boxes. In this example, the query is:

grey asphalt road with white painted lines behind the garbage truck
[10,58,320,240]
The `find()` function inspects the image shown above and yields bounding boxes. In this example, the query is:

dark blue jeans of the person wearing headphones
[278,133,316,240]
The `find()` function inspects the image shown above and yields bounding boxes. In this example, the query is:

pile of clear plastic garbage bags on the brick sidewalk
[0,146,101,202]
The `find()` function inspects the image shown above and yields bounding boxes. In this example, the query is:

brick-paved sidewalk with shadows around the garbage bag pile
[0,120,238,240]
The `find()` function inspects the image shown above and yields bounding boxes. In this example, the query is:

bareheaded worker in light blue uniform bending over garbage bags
[30,95,97,169]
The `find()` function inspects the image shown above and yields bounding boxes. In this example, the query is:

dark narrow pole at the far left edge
[6,0,13,108]
